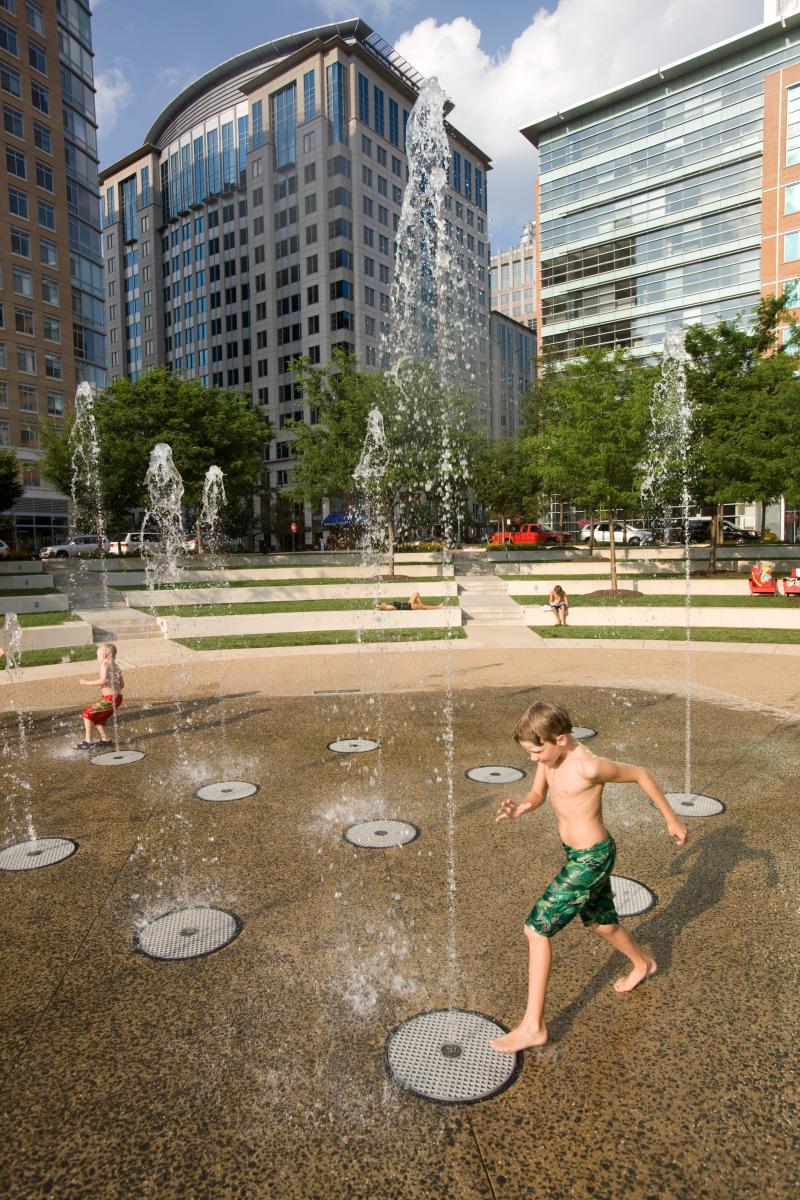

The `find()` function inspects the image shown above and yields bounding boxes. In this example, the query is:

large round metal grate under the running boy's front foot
[386,1008,519,1104]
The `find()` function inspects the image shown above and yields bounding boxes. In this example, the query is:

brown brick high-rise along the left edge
[0,0,104,550]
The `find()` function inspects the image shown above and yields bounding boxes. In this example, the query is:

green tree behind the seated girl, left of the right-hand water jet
[523,348,655,589]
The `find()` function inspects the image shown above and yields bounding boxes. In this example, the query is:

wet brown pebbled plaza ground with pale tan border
[0,648,800,1200]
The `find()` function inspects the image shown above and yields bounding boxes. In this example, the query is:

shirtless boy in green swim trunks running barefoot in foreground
[491,702,687,1054]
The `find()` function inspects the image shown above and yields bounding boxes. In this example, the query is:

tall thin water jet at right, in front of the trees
[642,329,692,797]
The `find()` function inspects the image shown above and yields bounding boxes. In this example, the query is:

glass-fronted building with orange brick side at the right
[523,6,800,355]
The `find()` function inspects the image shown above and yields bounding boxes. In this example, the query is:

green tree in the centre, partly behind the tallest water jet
[291,350,479,572]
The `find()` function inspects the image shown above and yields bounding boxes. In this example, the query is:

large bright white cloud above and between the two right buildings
[396,0,763,248]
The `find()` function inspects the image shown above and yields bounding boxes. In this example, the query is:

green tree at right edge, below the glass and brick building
[685,295,800,570]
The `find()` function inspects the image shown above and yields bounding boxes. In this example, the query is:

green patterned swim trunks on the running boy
[525,834,619,937]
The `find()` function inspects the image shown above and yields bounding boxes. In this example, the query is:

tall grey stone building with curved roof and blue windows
[101,19,489,541]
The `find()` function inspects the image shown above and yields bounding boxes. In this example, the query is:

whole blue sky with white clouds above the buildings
[92,0,763,248]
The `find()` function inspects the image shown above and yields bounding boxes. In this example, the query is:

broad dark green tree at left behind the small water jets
[42,368,271,528]
